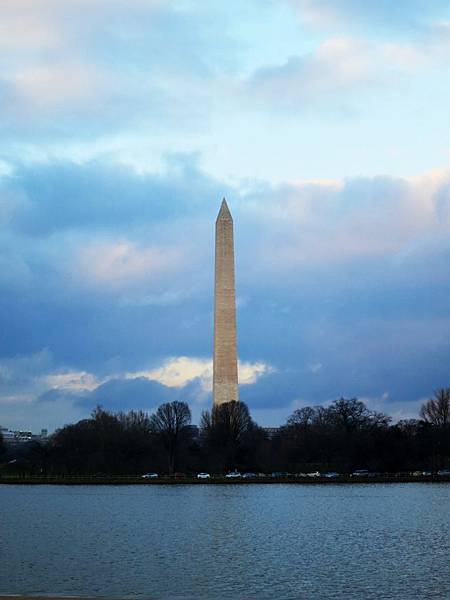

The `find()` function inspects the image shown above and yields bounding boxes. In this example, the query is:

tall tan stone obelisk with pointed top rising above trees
[213,198,239,405]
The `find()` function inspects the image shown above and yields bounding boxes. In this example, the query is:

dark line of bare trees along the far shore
[0,388,450,476]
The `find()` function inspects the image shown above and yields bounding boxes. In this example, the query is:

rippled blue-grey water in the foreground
[0,483,450,600]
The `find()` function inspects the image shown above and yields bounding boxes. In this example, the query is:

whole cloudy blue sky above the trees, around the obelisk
[0,0,450,432]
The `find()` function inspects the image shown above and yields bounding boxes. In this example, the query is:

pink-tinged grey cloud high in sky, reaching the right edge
[245,31,450,111]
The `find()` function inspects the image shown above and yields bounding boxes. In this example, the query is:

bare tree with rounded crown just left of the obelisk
[150,400,191,475]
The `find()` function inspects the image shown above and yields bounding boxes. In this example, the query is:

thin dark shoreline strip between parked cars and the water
[0,475,450,486]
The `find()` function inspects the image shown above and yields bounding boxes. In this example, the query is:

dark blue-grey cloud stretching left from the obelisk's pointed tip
[0,156,227,236]
